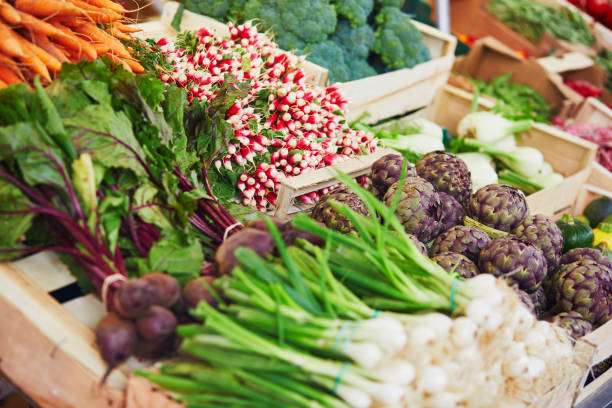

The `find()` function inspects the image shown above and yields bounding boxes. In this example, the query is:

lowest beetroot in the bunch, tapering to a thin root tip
[96,313,138,381]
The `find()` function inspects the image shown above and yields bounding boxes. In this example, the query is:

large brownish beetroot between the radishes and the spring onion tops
[215,228,275,275]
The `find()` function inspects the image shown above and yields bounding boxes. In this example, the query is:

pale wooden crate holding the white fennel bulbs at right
[427,85,597,216]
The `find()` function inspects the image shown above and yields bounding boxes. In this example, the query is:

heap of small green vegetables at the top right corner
[487,0,595,46]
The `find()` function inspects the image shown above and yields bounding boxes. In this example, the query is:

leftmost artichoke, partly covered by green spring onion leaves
[312,187,368,234]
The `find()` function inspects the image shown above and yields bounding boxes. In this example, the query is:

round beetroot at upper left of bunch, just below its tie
[113,279,155,319]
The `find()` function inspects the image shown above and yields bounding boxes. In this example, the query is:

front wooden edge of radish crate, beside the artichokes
[274,149,396,218]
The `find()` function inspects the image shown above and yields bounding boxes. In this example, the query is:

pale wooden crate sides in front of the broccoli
[338,21,457,123]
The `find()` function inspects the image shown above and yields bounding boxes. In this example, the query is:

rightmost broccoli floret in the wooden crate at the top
[374,7,431,69]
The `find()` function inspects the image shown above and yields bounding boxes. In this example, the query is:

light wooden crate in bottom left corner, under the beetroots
[0,252,175,408]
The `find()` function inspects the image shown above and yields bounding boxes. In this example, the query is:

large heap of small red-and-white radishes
[158,22,376,210]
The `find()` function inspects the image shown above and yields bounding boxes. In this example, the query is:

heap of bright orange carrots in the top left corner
[0,0,144,88]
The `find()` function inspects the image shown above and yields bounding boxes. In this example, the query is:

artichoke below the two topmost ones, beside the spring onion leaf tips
[383,177,442,242]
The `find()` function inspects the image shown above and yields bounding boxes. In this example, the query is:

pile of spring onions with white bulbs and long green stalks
[139,173,575,407]
